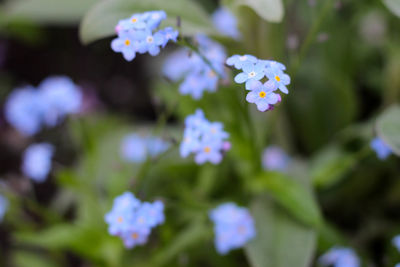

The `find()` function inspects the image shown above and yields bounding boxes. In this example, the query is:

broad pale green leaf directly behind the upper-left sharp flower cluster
[80,0,214,44]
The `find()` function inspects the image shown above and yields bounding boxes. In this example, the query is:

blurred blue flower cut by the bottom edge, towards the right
[319,247,360,267]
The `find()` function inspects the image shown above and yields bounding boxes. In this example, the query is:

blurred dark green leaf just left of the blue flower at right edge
[311,146,357,187]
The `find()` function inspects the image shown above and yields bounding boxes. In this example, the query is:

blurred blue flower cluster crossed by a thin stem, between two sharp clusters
[163,35,226,100]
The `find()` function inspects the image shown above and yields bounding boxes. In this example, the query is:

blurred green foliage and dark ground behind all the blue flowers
[0,0,400,267]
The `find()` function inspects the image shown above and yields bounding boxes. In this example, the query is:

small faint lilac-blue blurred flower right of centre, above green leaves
[262,146,290,171]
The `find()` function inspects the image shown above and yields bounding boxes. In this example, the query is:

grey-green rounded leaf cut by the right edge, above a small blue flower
[376,105,400,156]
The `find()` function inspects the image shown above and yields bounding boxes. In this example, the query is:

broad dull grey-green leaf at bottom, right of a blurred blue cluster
[245,197,316,267]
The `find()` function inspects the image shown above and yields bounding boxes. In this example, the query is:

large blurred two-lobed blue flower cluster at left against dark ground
[5,76,82,136]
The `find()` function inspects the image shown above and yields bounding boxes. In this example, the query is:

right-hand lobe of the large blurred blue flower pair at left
[38,76,82,126]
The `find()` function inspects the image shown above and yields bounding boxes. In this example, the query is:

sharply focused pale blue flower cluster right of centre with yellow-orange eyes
[226,55,290,111]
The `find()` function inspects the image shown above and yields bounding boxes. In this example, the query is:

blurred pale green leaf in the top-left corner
[4,0,99,24]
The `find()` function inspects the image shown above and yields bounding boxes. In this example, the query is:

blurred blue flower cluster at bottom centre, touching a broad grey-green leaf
[210,203,256,254]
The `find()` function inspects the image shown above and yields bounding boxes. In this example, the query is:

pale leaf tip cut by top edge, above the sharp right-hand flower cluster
[234,0,284,22]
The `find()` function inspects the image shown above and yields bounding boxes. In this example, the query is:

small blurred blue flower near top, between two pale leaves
[212,7,241,39]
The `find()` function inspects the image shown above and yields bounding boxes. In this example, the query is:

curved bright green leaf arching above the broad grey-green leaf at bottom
[253,172,322,227]
